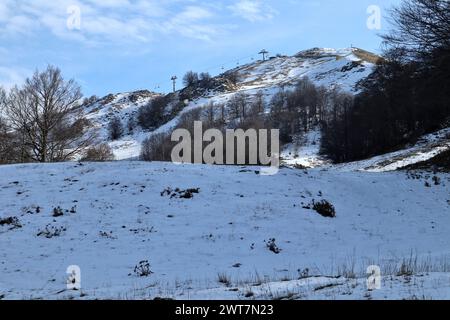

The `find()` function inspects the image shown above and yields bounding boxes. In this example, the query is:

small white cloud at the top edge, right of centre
[228,0,277,22]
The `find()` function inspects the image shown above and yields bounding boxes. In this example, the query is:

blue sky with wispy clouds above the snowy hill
[0,0,400,96]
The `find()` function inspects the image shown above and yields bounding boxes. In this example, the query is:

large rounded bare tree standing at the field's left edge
[6,66,95,162]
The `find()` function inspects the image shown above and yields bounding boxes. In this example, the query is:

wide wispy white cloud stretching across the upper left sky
[0,0,226,44]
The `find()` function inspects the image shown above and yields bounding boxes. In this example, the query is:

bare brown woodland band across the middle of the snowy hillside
[139,78,353,163]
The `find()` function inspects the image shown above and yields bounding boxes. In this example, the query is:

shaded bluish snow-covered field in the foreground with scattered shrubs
[0,161,450,299]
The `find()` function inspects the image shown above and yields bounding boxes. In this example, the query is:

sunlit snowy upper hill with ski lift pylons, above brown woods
[86,48,379,160]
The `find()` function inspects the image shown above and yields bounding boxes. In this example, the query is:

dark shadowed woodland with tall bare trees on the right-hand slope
[323,0,450,162]
